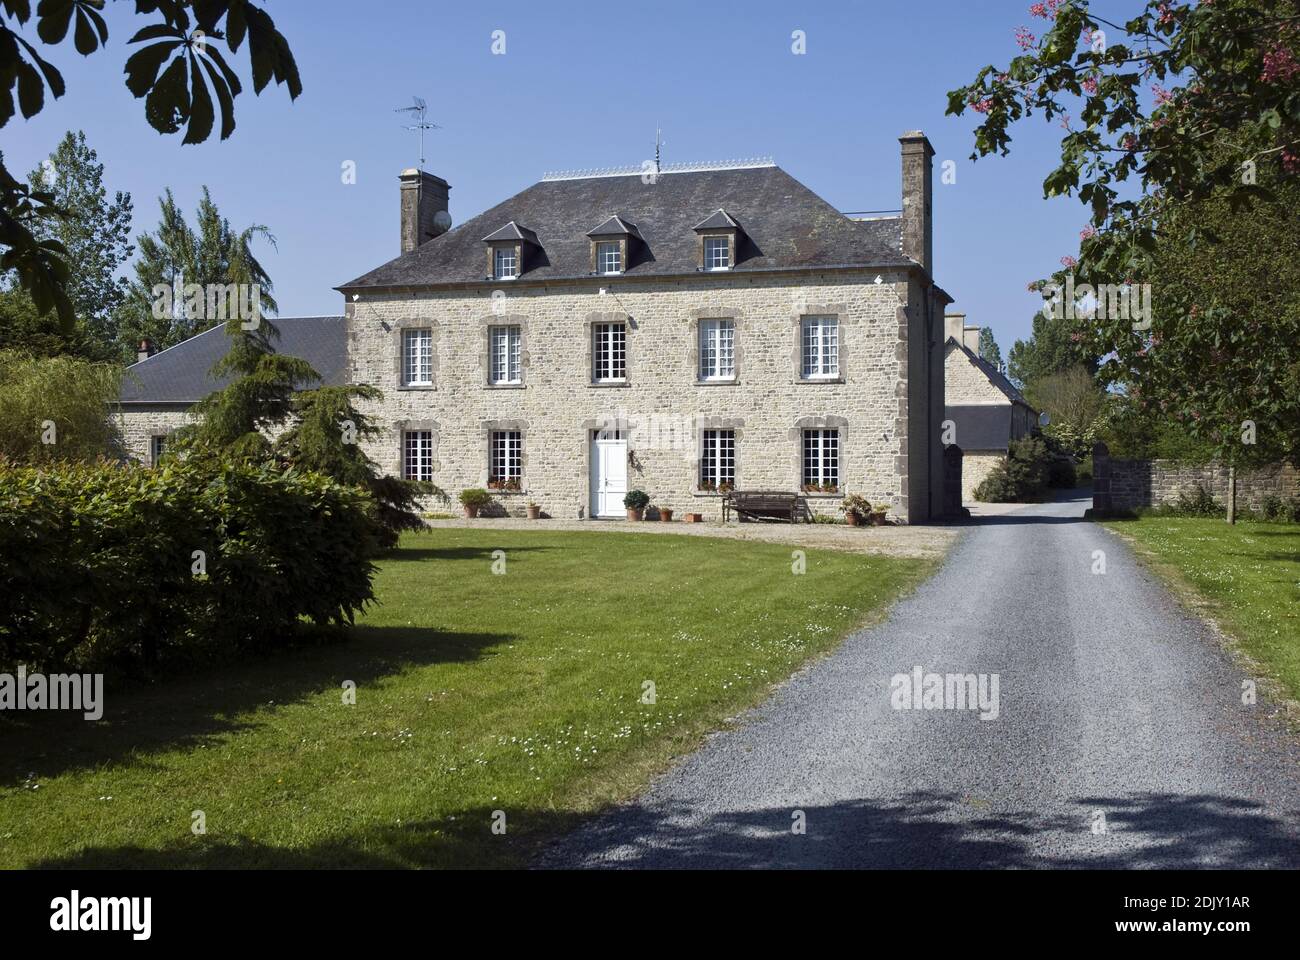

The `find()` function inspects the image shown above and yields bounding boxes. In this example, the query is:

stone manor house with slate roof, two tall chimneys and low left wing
[122,131,952,523]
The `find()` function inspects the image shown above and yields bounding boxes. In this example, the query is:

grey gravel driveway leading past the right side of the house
[540,500,1300,868]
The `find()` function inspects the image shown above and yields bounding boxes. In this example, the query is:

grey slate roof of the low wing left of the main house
[121,316,347,403]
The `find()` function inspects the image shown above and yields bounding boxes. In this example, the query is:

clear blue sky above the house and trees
[4,0,1134,356]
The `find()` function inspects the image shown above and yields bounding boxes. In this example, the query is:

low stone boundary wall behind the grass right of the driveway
[1092,444,1300,511]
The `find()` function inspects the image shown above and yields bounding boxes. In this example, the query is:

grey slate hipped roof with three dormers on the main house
[339,167,914,290]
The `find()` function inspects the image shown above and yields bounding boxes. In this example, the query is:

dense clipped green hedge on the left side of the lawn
[0,462,378,670]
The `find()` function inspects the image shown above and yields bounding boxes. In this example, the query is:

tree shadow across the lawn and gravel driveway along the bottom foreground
[25,791,1300,869]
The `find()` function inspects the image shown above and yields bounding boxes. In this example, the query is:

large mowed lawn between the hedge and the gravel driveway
[0,529,932,868]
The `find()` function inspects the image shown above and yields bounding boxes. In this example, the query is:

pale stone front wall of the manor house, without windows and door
[347,272,937,519]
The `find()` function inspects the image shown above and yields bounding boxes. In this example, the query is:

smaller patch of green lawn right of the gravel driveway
[1108,516,1300,700]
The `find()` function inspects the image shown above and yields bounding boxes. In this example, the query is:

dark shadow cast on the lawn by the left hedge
[0,626,517,786]
